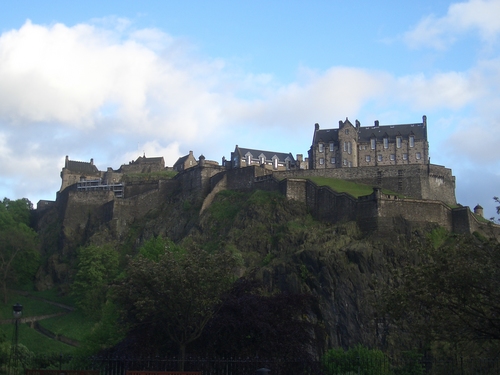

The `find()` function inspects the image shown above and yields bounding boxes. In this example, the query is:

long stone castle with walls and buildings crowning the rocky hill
[38,116,500,238]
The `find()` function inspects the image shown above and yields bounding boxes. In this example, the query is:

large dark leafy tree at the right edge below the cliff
[384,231,500,356]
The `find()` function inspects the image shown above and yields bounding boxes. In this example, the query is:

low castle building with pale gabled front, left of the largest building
[229,145,297,171]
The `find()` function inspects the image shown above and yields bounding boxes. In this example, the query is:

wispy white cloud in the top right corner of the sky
[404,0,500,50]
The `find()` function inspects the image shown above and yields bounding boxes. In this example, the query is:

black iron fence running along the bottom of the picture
[14,355,500,375]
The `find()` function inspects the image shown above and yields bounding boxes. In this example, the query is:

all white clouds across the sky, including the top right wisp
[0,9,500,217]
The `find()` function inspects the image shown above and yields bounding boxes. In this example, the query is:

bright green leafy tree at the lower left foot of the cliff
[71,245,119,319]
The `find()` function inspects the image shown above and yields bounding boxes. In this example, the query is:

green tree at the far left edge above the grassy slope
[0,198,39,303]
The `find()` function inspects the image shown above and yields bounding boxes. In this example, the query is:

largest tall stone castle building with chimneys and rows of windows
[309,116,429,169]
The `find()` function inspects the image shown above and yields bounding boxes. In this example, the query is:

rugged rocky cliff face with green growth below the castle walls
[37,186,432,356]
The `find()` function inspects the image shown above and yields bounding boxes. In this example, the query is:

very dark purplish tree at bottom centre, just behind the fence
[191,279,325,360]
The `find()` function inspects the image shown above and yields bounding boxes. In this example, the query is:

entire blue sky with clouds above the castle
[0,0,500,218]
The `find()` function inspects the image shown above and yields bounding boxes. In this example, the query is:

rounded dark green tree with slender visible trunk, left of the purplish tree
[115,248,237,371]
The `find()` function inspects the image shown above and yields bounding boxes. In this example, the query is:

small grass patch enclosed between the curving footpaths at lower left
[38,310,95,341]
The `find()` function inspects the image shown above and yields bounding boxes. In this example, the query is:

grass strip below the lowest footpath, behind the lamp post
[0,324,75,354]
